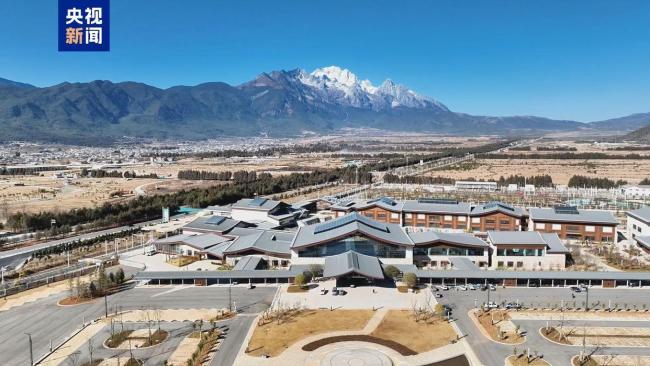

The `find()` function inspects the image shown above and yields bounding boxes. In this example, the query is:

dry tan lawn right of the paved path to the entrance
[370,310,456,353]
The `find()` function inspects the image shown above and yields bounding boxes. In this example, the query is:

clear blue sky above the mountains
[0,0,650,122]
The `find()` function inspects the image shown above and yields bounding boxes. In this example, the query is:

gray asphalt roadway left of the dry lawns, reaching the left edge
[0,286,276,366]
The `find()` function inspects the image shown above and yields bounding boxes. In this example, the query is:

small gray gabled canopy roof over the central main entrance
[323,251,384,278]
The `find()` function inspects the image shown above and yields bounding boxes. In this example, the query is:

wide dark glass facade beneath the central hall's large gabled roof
[298,235,406,258]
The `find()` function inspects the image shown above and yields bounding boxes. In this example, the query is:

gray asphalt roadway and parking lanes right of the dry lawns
[439,288,650,366]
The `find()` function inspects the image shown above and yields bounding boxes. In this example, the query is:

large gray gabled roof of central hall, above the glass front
[292,212,413,248]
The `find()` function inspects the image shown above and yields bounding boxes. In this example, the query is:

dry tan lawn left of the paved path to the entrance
[246,310,373,357]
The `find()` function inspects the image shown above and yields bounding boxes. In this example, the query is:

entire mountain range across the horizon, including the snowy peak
[0,66,650,145]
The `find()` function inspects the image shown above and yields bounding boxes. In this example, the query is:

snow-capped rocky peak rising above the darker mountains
[243,66,448,111]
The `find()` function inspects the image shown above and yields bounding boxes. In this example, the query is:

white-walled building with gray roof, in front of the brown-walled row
[487,231,569,271]
